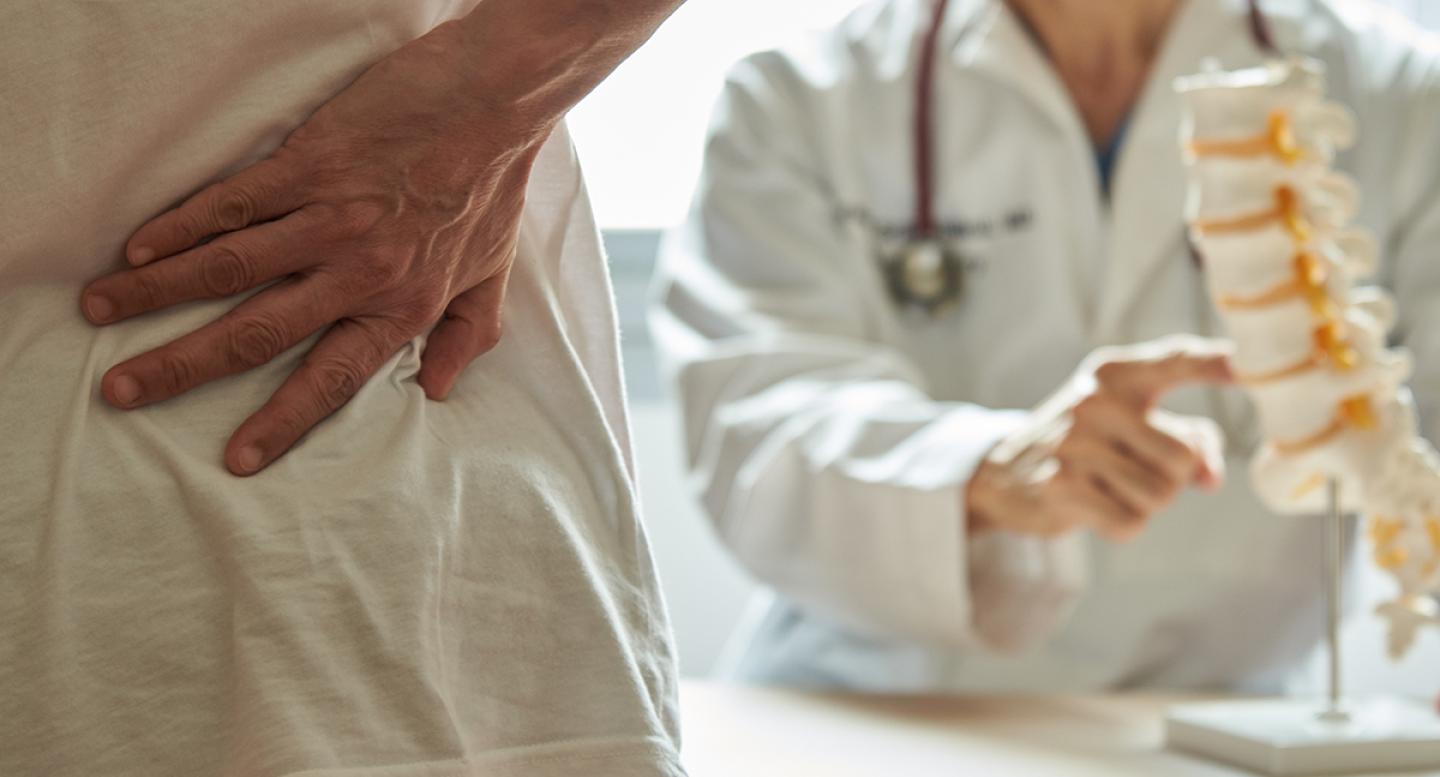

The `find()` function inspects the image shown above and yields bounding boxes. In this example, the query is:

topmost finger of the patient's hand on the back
[125,153,304,266]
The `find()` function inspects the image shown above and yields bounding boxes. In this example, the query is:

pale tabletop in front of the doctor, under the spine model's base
[681,681,1440,777]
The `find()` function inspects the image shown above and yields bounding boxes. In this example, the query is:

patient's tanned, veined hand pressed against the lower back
[81,23,557,475]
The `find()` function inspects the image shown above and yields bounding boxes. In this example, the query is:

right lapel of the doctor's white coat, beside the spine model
[1096,0,1263,342]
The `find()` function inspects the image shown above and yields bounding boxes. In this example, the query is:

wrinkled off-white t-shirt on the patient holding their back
[0,0,681,777]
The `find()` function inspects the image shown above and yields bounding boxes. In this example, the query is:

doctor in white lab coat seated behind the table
[652,0,1440,691]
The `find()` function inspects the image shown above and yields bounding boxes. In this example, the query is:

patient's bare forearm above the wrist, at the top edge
[459,0,683,134]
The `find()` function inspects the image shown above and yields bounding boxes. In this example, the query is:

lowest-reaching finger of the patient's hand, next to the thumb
[225,318,408,476]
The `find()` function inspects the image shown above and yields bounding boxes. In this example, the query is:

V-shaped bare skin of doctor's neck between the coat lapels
[1007,0,1181,147]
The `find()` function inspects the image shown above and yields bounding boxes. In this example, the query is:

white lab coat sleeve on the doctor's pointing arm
[651,60,1083,652]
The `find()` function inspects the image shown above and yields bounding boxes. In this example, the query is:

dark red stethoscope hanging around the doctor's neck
[880,0,1279,315]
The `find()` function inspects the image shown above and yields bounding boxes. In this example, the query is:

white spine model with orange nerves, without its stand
[1176,60,1440,658]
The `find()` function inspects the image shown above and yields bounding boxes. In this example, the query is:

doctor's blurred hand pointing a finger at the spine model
[965,337,1231,541]
